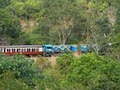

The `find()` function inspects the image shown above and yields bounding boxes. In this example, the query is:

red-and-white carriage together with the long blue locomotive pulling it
[0,45,78,56]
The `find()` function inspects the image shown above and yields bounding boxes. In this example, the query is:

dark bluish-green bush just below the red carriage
[0,56,40,87]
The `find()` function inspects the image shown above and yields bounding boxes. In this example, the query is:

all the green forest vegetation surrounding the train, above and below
[0,0,120,90]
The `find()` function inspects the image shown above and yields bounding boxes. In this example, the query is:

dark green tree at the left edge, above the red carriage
[0,9,21,45]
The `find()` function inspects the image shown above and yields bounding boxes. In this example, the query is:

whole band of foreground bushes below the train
[0,53,120,90]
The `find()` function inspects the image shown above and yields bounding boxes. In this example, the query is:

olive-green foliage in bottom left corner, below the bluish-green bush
[0,71,32,90]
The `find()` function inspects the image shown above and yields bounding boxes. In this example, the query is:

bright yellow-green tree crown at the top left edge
[6,0,41,20]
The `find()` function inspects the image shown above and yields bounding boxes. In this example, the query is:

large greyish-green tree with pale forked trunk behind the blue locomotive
[34,0,85,44]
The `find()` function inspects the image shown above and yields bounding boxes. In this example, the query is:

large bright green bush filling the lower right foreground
[58,54,120,90]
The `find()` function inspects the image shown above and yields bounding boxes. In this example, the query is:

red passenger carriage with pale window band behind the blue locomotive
[0,45,44,55]
